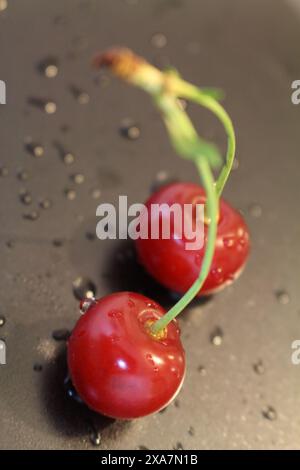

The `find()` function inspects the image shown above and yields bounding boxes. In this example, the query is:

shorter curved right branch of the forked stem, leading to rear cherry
[183,86,236,197]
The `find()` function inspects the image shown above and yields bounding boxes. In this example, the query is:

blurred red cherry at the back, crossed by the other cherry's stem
[136,183,249,296]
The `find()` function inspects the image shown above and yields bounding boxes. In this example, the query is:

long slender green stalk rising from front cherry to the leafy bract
[151,156,218,334]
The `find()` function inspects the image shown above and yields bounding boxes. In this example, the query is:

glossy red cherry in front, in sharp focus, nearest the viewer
[68,292,185,419]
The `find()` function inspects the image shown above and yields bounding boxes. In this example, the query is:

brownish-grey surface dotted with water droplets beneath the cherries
[0,0,300,449]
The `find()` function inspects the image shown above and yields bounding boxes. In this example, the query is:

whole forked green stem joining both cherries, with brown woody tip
[94,48,236,335]
